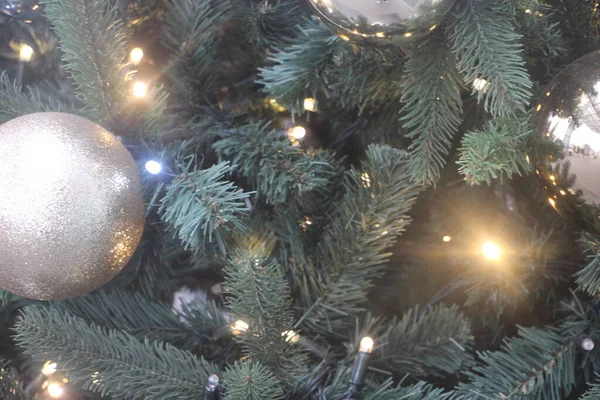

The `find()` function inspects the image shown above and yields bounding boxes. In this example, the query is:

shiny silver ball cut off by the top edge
[310,0,450,46]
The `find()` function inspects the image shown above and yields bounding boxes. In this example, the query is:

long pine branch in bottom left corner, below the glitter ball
[15,306,217,400]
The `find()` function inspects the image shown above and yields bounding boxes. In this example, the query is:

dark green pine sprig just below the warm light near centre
[213,123,339,204]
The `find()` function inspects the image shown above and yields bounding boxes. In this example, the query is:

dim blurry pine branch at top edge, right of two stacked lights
[162,0,230,104]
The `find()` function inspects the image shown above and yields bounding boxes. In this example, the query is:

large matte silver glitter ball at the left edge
[0,113,145,300]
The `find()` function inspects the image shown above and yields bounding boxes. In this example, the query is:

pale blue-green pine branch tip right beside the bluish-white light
[159,160,249,253]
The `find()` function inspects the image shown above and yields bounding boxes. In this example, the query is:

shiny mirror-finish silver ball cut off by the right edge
[535,51,600,205]
